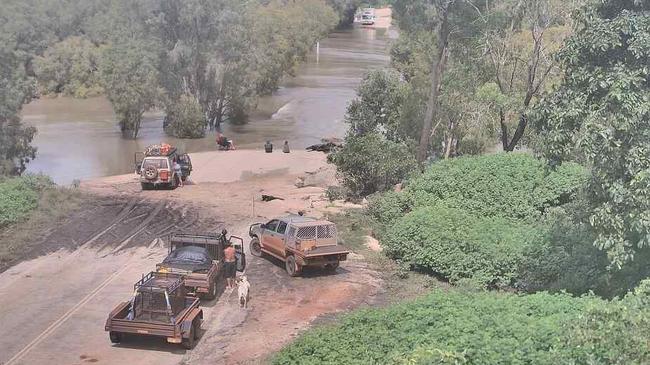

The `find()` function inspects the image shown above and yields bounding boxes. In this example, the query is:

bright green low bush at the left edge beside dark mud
[0,175,53,227]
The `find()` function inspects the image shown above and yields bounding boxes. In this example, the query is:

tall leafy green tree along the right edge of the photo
[534,1,650,268]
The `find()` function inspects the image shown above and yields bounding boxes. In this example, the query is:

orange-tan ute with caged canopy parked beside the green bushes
[248,215,350,276]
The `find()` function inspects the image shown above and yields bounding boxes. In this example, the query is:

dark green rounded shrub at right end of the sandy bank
[328,133,417,196]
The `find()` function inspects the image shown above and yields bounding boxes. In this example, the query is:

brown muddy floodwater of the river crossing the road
[23,28,396,184]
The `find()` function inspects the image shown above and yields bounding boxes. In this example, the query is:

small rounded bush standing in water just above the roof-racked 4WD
[165,95,205,138]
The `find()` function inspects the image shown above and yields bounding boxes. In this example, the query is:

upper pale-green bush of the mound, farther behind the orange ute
[392,153,587,221]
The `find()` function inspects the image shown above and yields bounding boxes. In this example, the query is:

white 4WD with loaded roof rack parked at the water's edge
[135,144,192,190]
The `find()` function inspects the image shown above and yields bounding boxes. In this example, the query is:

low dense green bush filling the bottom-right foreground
[273,283,650,365]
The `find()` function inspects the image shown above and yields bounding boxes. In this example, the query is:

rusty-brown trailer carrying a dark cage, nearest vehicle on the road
[104,272,203,349]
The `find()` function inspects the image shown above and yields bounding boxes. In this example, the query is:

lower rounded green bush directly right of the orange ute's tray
[382,205,547,287]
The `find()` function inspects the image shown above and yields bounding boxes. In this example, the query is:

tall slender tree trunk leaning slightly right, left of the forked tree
[417,1,453,163]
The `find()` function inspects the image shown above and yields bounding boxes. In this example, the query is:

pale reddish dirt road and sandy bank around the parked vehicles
[0,151,381,365]
